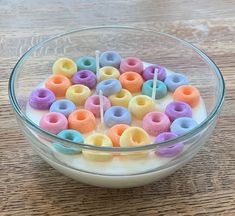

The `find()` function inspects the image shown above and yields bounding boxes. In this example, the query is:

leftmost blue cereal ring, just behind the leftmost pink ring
[50,99,76,117]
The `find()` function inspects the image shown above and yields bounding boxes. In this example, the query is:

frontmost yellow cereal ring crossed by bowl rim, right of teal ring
[82,133,113,161]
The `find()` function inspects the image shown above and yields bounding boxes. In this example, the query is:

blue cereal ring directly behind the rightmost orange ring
[164,73,189,92]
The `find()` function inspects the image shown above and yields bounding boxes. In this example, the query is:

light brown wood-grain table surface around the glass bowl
[0,0,235,216]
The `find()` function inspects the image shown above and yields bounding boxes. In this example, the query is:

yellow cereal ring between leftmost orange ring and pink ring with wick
[65,84,91,106]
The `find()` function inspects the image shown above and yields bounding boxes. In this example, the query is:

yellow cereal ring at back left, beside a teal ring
[52,58,77,79]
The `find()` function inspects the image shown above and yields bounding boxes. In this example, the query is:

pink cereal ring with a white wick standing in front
[85,95,111,117]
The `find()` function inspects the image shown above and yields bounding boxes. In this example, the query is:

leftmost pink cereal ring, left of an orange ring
[39,112,68,134]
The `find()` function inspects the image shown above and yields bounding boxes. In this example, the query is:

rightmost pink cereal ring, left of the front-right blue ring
[142,112,171,136]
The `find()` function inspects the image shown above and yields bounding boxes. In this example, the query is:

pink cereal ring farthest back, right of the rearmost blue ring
[120,57,144,74]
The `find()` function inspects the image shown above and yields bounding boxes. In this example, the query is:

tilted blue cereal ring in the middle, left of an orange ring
[96,79,122,97]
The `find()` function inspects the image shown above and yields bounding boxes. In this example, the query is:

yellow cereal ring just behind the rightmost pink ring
[128,95,155,120]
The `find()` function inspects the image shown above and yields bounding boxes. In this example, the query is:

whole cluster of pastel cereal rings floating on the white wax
[28,51,201,161]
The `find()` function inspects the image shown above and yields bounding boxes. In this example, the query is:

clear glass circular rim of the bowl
[8,25,225,152]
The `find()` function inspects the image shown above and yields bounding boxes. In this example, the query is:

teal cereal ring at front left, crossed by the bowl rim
[53,130,84,154]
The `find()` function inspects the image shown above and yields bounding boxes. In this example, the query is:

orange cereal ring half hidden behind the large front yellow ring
[108,124,129,147]
